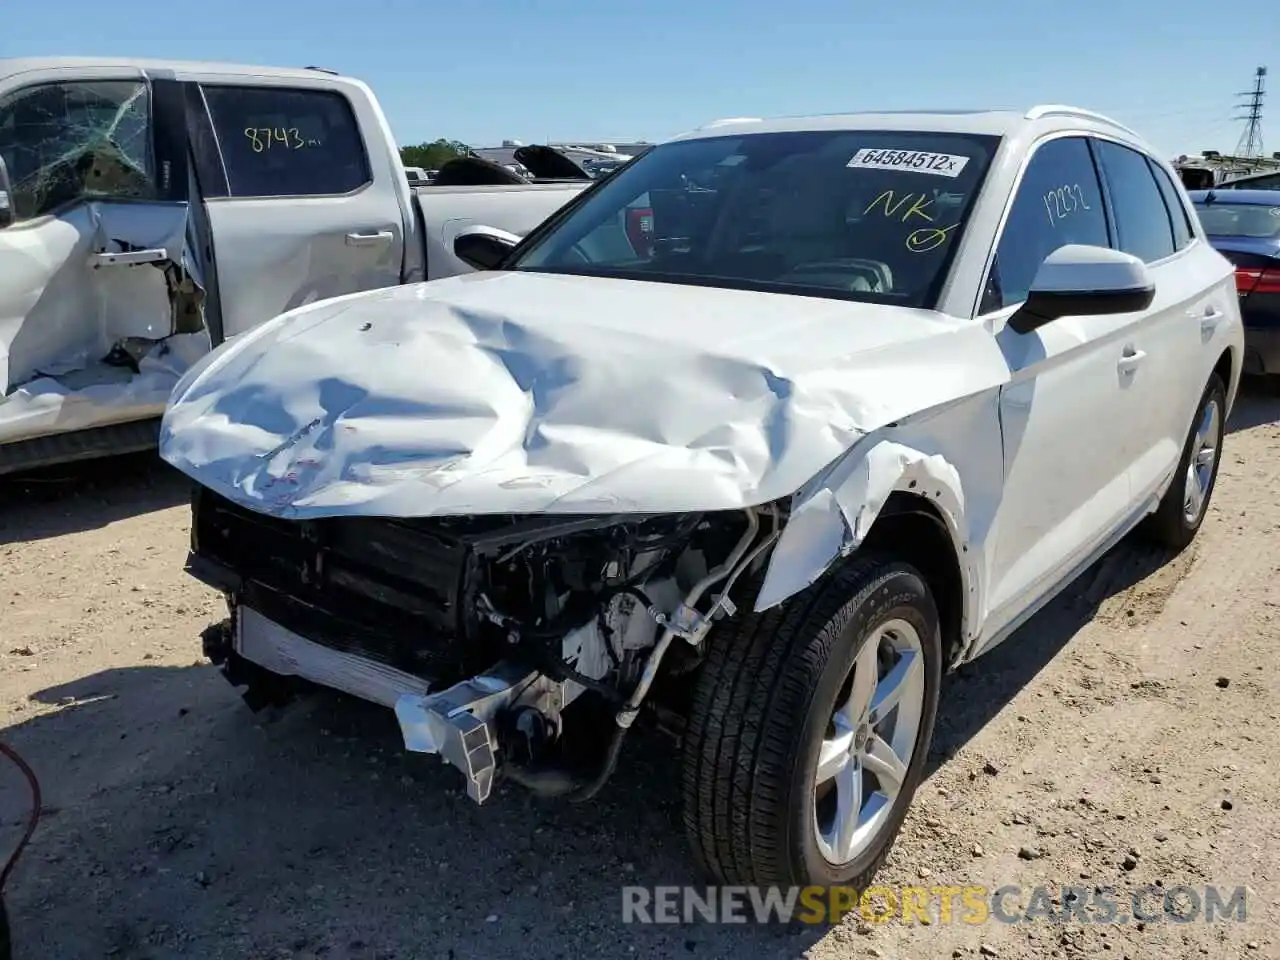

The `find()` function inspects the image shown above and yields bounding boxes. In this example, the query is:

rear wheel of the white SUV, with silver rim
[1142,374,1226,550]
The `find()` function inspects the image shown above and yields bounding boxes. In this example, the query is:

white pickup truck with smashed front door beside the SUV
[0,58,590,474]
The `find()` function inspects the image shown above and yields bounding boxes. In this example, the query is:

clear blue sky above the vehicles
[0,0,1280,154]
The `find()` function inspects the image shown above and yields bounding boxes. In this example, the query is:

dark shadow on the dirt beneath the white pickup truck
[0,453,191,545]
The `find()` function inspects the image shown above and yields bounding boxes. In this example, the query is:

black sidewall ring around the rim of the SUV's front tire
[787,563,942,884]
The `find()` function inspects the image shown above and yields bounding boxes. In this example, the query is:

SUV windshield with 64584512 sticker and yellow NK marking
[509,131,998,307]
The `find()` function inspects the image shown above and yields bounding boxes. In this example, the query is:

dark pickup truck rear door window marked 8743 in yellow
[204,86,372,197]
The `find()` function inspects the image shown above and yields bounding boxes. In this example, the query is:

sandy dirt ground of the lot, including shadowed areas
[0,394,1280,960]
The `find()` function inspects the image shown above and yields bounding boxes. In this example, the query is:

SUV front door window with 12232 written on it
[979,137,1108,314]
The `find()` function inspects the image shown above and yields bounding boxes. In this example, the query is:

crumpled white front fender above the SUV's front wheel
[755,389,1004,648]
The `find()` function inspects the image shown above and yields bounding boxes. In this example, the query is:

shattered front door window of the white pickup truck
[0,81,155,220]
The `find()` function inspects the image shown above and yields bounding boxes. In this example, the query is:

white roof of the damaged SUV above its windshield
[673,104,1140,140]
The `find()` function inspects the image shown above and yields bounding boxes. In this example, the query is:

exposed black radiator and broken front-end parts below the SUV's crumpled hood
[188,489,781,803]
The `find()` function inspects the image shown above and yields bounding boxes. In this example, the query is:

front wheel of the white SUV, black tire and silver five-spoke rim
[684,557,942,887]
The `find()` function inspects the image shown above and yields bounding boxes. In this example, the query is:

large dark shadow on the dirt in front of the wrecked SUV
[0,667,822,960]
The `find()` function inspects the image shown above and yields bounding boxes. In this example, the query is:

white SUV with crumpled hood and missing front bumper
[161,106,1243,884]
